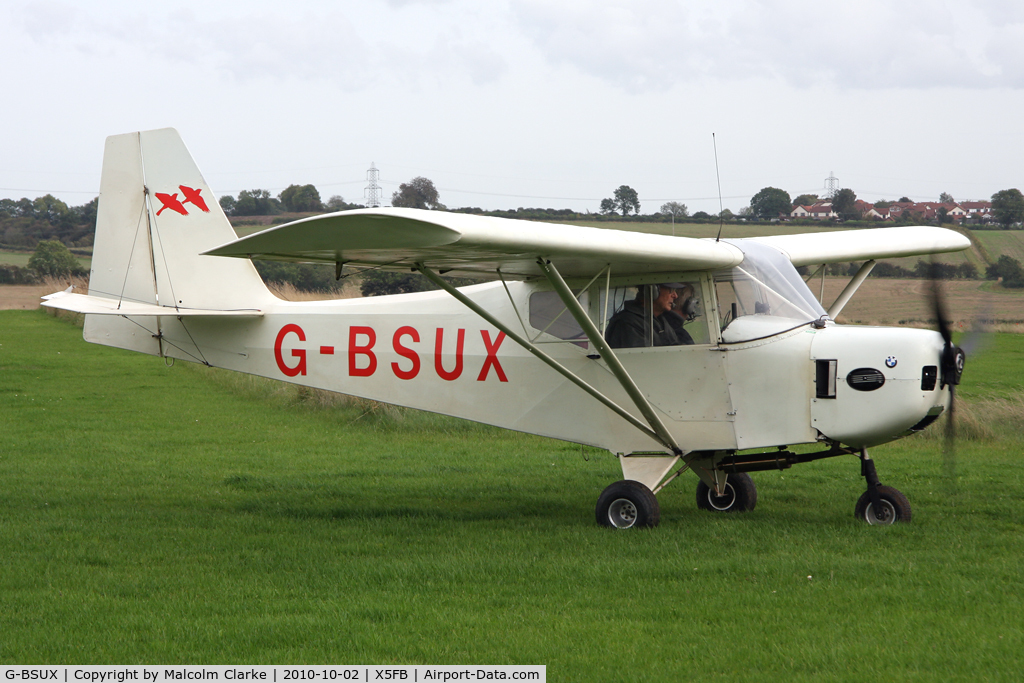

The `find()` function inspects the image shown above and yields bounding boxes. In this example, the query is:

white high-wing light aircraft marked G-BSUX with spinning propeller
[44,129,970,527]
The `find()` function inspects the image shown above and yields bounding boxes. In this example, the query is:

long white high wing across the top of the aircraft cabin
[204,208,971,279]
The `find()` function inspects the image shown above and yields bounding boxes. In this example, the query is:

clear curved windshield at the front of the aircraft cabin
[715,240,827,342]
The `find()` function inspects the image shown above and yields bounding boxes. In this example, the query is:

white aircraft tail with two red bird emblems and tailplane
[44,128,275,355]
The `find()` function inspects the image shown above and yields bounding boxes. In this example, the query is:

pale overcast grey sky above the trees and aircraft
[0,0,1024,213]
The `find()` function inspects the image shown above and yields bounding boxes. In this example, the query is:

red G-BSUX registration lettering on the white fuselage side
[273,323,509,382]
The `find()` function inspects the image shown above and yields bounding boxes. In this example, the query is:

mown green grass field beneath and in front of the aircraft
[0,311,1024,681]
